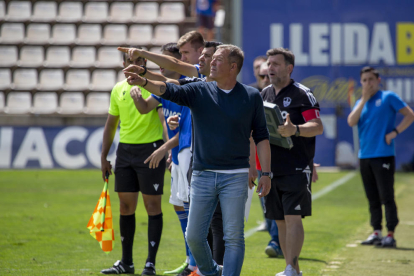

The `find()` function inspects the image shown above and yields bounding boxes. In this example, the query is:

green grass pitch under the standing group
[0,170,414,276]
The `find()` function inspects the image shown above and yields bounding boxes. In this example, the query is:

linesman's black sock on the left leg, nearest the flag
[119,214,135,265]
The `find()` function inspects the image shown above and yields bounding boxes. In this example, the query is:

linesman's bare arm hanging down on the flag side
[101,114,119,181]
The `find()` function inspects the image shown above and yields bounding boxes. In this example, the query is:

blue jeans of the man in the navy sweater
[186,171,248,276]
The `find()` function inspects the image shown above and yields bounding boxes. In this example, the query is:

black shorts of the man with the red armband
[264,169,312,220]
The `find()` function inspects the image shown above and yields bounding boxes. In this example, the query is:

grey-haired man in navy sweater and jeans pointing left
[120,45,271,276]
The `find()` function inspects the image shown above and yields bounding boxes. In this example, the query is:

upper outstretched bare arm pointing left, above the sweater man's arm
[118,47,198,77]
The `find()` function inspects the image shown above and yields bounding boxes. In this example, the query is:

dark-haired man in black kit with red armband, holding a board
[261,48,323,276]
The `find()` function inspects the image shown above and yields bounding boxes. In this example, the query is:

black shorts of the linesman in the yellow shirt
[115,140,165,195]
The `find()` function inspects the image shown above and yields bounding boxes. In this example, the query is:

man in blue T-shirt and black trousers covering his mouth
[348,67,414,247]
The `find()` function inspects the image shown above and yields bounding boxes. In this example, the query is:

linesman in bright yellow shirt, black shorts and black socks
[101,50,165,275]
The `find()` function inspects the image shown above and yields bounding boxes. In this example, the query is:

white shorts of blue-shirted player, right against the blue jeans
[177,148,193,202]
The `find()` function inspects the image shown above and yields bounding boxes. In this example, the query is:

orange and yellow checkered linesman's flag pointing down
[87,174,115,254]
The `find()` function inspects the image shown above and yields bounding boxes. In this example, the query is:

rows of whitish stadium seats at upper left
[0,0,189,117]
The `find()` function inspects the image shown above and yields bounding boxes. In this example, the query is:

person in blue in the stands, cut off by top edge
[195,0,219,41]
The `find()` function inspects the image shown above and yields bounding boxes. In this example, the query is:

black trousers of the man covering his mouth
[360,156,398,231]
